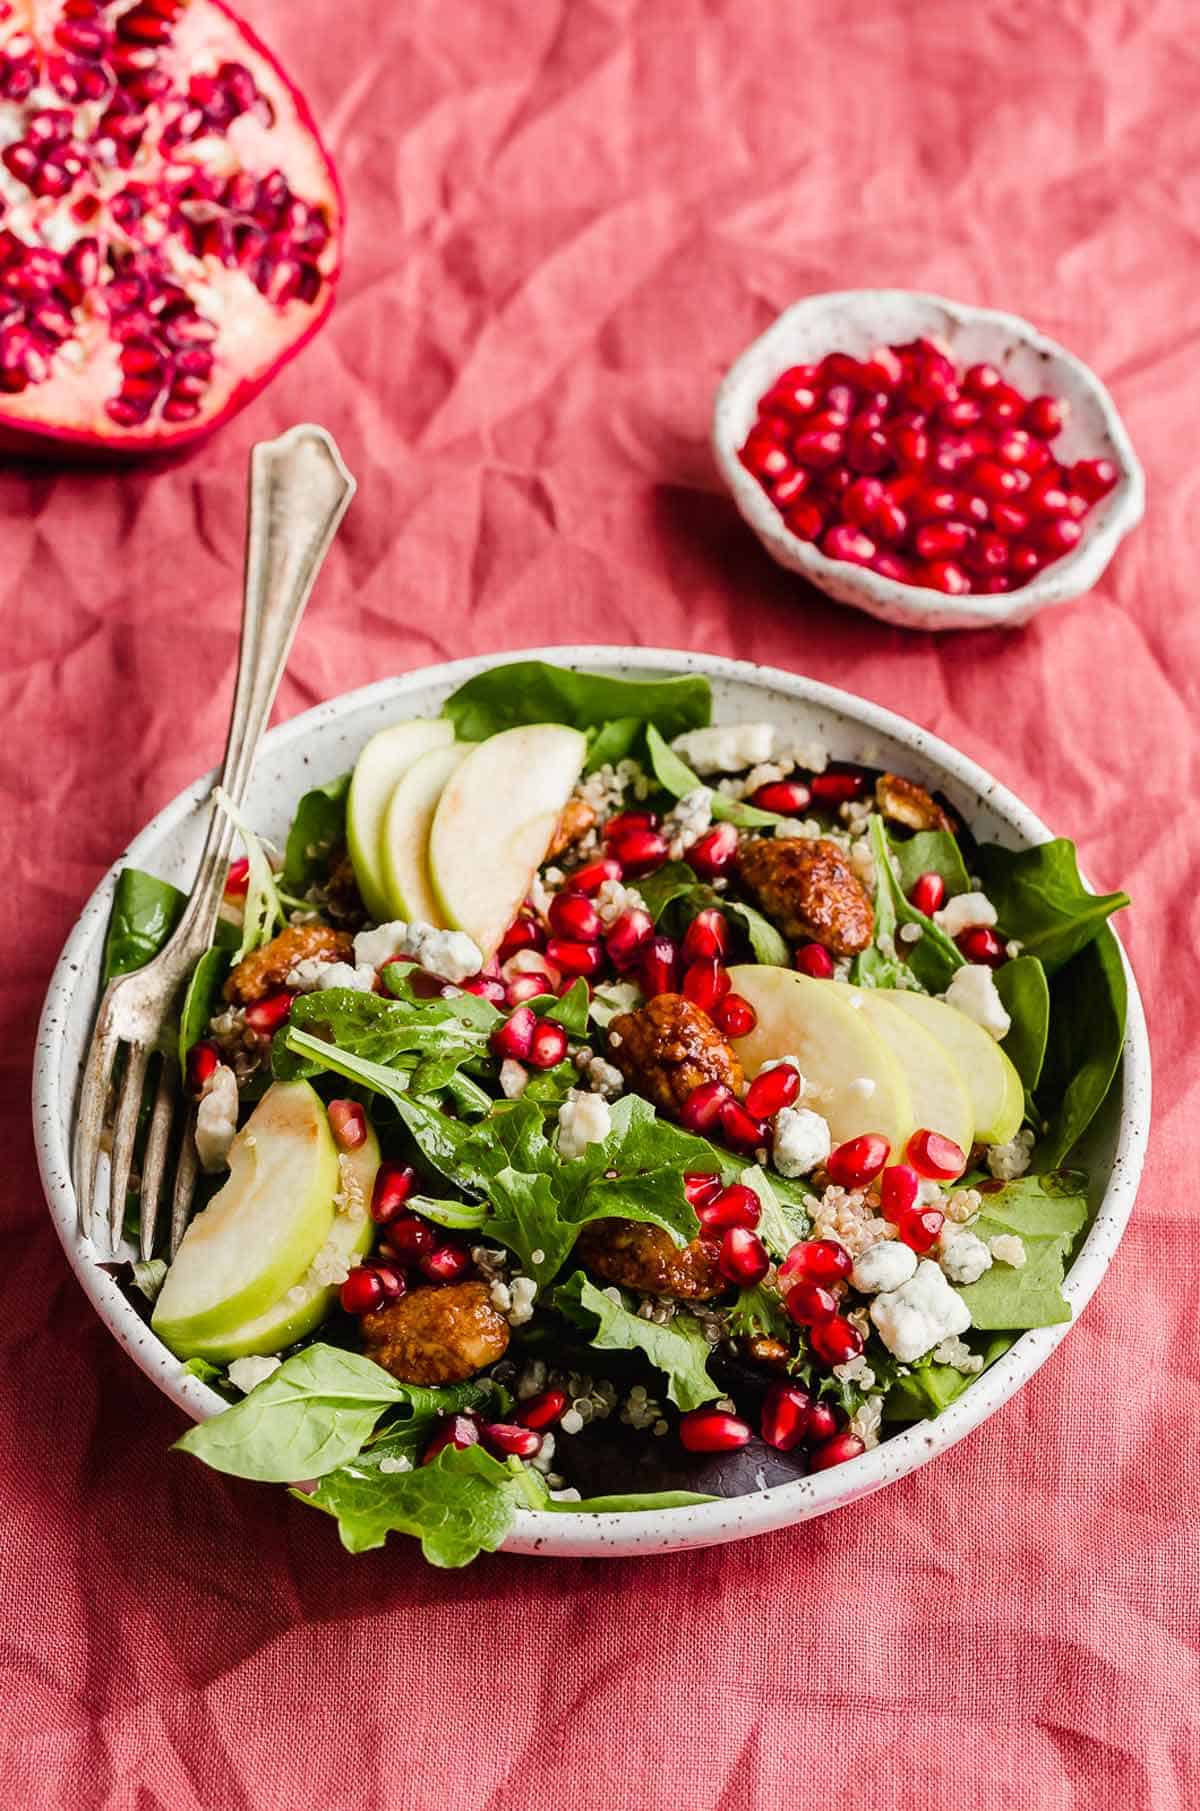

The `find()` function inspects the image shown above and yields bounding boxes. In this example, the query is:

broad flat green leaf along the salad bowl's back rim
[442,661,713,746]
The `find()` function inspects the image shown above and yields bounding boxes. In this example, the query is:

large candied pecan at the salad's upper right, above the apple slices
[738,837,874,956]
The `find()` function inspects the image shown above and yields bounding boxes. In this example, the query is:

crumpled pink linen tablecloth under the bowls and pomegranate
[0,0,1200,1811]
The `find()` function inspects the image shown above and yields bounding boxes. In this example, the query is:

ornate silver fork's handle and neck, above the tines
[171,422,355,945]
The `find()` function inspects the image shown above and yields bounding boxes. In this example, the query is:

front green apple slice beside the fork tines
[150,1081,340,1358]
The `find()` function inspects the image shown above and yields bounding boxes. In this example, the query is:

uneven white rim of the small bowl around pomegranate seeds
[711,288,1146,628]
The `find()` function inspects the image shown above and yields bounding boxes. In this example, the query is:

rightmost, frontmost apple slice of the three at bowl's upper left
[429,723,588,962]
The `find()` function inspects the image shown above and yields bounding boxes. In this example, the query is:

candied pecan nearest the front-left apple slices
[362,1282,509,1384]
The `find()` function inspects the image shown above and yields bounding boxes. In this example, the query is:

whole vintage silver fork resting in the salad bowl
[74,426,355,1259]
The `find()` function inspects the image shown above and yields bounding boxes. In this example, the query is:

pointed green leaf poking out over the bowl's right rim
[974,837,1129,974]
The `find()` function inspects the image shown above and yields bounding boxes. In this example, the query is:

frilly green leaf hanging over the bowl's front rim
[305,1427,519,1567]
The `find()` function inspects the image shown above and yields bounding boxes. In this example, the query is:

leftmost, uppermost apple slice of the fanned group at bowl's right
[729,965,918,1150]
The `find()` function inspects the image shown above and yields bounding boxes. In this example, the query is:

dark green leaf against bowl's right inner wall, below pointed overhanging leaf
[1035,925,1128,1170]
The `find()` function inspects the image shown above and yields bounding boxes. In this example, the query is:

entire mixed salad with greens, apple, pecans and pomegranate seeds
[105,663,1128,1565]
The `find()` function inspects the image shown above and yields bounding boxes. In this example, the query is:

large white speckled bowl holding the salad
[33,648,1149,1557]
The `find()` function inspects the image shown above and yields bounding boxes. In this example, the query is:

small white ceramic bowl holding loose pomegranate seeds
[713,290,1146,628]
